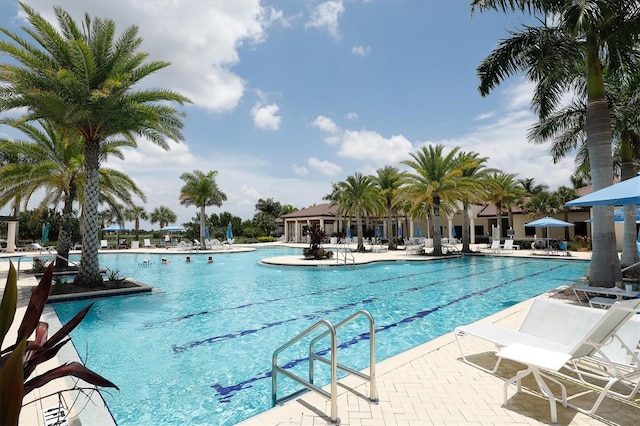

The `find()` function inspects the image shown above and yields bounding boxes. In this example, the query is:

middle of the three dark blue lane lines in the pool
[171,265,528,354]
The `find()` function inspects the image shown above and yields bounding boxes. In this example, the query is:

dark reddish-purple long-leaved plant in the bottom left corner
[0,262,118,425]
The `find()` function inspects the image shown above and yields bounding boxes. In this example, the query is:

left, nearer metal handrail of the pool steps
[271,319,340,423]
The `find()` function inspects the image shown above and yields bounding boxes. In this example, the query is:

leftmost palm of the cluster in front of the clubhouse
[331,172,382,252]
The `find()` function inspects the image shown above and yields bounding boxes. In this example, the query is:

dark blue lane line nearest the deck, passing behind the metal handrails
[211,265,567,403]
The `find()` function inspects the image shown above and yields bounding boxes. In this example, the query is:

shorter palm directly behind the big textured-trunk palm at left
[0,119,144,267]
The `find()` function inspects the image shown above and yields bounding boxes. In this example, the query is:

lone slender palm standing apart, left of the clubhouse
[179,170,227,244]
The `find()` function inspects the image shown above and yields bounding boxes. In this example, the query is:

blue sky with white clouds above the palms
[0,0,573,223]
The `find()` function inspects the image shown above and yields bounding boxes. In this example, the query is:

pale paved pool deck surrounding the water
[0,245,640,426]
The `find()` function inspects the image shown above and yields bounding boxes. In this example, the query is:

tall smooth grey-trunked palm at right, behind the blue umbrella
[471,0,640,287]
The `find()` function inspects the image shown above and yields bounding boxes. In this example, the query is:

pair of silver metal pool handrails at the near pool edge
[271,311,378,424]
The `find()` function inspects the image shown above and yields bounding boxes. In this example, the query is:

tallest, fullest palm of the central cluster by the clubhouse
[402,145,470,255]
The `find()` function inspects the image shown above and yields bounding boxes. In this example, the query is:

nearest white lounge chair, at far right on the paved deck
[484,299,640,423]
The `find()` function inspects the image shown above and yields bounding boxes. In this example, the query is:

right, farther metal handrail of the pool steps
[309,310,378,402]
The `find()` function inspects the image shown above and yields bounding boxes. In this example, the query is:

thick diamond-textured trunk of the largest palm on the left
[75,141,102,287]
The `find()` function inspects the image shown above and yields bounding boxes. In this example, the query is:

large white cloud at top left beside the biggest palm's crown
[27,0,276,113]
